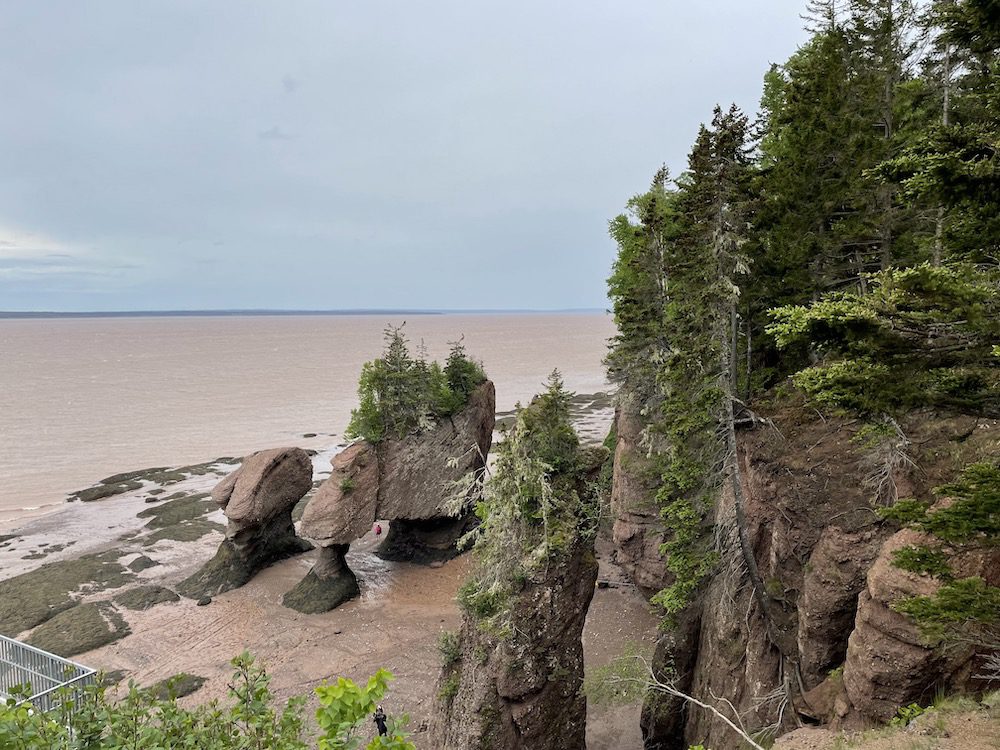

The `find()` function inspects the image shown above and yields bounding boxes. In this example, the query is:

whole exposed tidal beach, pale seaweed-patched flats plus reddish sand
[0,393,658,750]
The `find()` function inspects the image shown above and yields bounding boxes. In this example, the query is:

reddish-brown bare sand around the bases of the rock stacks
[75,534,656,750]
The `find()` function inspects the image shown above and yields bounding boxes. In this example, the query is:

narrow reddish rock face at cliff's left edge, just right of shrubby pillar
[611,403,667,595]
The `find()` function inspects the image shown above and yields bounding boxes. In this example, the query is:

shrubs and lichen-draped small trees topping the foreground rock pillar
[459,371,593,632]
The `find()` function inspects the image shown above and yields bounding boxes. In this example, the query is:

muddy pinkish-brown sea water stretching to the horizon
[0,314,614,529]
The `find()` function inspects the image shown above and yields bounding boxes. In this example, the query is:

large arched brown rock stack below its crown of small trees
[284,381,496,613]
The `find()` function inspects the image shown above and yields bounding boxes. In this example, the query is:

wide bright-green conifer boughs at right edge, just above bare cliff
[768,263,1000,415]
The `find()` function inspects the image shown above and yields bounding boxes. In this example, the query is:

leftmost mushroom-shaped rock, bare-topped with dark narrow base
[177,448,312,599]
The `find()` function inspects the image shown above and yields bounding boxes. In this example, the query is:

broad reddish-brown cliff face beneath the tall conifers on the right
[615,407,1000,750]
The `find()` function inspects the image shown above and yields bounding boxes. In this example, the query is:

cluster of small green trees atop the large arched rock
[346,326,486,444]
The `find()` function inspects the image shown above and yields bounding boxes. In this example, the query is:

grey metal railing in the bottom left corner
[0,635,97,712]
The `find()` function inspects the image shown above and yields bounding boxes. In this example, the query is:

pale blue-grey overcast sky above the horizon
[0,0,804,310]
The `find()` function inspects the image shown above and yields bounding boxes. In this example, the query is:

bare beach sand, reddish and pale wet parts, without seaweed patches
[0,398,657,750]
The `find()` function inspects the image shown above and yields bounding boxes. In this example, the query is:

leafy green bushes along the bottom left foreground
[0,652,414,750]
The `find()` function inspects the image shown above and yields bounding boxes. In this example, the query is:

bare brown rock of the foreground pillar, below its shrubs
[430,540,597,750]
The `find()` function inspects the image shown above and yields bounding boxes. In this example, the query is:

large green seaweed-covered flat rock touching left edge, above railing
[0,553,133,637]
